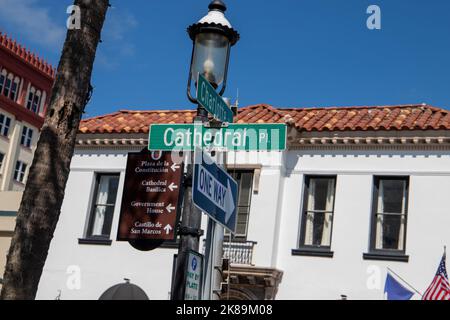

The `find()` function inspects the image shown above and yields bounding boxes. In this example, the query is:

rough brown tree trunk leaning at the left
[1,0,109,300]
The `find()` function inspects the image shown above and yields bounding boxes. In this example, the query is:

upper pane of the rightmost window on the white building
[378,180,406,213]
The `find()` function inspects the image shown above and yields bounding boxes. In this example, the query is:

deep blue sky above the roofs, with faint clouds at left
[0,0,450,116]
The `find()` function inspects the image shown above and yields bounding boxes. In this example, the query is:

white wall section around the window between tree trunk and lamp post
[37,152,176,299]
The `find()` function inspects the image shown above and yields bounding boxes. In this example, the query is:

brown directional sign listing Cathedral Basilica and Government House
[117,152,183,241]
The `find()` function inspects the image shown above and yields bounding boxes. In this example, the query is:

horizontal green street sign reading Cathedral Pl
[148,124,287,151]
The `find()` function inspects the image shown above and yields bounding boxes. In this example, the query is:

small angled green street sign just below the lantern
[197,74,233,123]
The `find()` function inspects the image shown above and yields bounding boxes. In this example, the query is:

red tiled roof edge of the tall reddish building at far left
[0,32,56,78]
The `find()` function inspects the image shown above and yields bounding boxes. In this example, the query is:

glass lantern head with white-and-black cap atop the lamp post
[187,0,239,107]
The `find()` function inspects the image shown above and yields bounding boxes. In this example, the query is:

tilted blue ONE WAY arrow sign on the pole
[192,153,238,233]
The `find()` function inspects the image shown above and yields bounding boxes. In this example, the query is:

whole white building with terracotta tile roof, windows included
[37,105,450,300]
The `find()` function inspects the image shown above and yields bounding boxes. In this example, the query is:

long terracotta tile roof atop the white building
[80,104,450,133]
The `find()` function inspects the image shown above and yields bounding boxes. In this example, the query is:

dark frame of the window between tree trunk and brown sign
[85,172,121,244]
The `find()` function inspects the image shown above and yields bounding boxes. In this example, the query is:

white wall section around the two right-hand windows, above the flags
[277,151,450,299]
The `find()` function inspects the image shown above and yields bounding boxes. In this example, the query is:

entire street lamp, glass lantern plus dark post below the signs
[172,0,239,300]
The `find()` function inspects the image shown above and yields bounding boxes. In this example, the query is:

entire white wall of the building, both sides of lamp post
[38,146,450,299]
